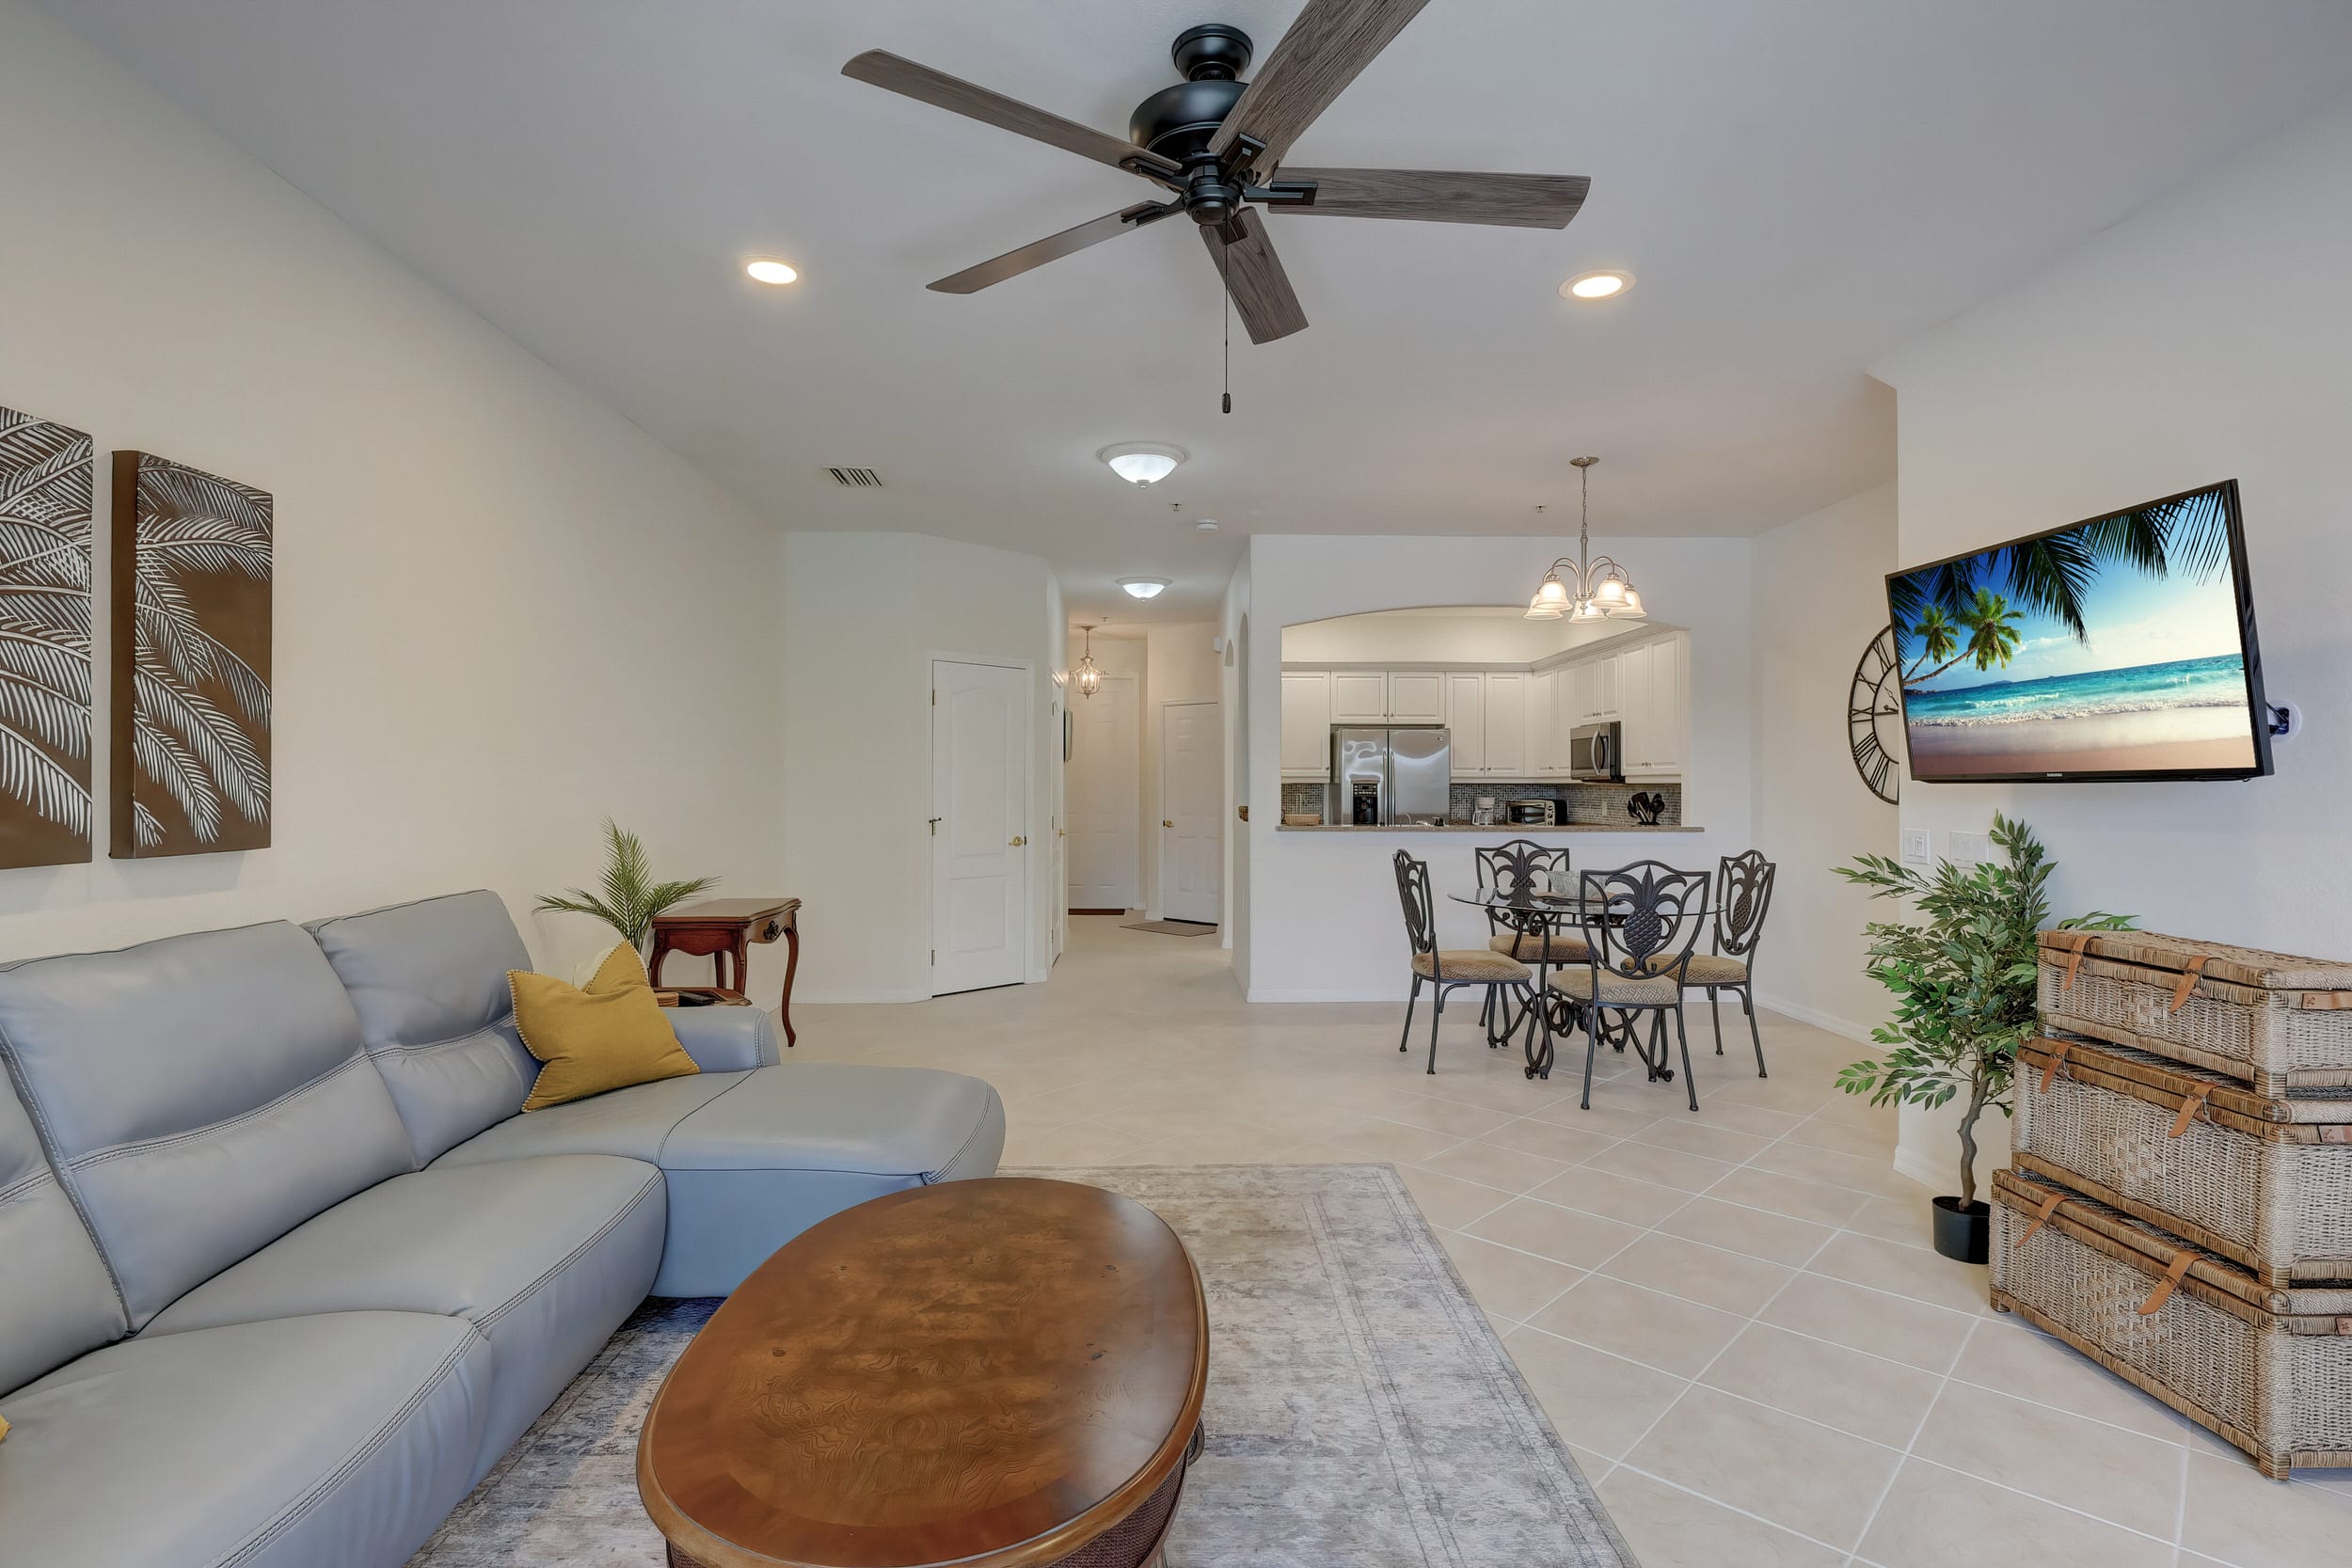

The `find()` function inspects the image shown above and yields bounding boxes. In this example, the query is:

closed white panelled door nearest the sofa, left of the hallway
[931,658,1028,997]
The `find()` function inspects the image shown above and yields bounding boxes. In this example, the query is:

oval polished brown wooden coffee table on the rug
[638,1178,1209,1568]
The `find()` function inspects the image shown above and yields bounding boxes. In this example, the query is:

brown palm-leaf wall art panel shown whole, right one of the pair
[108,451,273,858]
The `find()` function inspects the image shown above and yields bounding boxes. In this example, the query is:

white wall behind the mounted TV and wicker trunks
[1877,88,2352,1189]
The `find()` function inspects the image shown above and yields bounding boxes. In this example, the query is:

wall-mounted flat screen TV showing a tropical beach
[1886,480,2270,783]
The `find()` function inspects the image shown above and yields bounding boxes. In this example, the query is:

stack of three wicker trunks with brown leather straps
[1993,931,2352,1477]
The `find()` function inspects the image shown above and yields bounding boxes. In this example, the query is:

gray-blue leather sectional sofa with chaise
[0,894,1005,1568]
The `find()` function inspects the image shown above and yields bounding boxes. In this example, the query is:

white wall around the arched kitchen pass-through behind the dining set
[1235,533,1755,1002]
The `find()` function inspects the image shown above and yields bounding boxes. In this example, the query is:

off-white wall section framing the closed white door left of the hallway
[781,533,1066,1002]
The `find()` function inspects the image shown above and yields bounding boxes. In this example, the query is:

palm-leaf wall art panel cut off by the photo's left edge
[0,409,92,867]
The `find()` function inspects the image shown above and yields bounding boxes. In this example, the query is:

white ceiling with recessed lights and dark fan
[47,0,2352,621]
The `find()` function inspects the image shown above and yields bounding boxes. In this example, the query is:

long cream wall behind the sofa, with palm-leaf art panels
[0,0,784,985]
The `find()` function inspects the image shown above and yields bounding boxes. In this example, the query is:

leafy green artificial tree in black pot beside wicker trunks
[1835,814,2131,1262]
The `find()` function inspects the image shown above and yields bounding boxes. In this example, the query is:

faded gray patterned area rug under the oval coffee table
[409,1166,1635,1568]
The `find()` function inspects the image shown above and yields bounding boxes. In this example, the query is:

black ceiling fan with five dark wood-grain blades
[842,0,1593,343]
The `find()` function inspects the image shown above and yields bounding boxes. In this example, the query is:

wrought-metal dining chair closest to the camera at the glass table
[1548,861,1712,1110]
